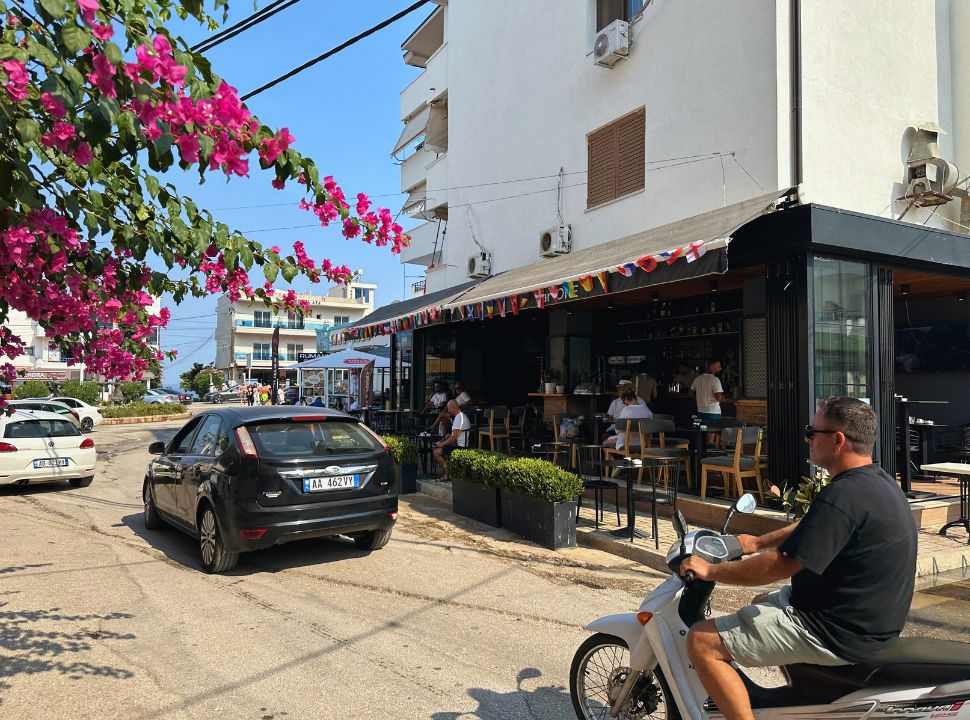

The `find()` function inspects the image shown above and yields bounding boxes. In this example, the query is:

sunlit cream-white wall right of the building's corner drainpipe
[802,0,970,230]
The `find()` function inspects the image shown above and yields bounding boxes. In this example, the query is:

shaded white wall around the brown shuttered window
[420,0,776,291]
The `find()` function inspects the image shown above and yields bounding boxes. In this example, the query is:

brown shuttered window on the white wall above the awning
[586,108,647,208]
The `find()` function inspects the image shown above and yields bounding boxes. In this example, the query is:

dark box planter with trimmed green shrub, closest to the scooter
[501,458,583,550]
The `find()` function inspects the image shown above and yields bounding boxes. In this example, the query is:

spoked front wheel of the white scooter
[569,633,680,720]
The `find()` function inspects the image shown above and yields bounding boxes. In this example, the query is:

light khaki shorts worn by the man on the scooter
[714,586,849,667]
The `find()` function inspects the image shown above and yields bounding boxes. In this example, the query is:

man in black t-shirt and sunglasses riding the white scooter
[680,397,916,720]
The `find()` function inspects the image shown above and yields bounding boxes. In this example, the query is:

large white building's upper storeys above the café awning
[394,0,970,293]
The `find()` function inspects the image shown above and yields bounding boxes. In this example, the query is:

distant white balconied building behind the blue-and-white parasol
[216,282,377,382]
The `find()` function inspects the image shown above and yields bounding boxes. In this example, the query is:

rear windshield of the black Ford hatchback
[246,420,382,457]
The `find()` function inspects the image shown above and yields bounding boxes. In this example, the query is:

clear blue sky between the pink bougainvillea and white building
[162,0,422,385]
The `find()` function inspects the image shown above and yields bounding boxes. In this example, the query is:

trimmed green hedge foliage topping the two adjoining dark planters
[448,450,583,502]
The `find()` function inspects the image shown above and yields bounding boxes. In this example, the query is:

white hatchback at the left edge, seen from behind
[0,410,97,487]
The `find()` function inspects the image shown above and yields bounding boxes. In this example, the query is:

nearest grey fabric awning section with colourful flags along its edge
[443,190,789,310]
